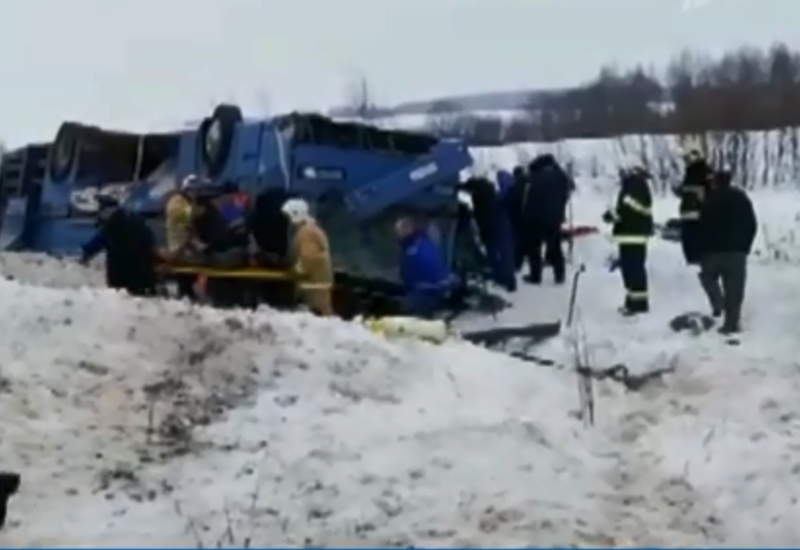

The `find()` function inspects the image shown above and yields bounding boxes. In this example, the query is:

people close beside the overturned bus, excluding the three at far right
[81,154,574,317]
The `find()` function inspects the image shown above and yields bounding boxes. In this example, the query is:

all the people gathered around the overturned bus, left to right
[75,149,757,334]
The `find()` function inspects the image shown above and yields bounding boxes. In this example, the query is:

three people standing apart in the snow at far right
[603,148,758,334]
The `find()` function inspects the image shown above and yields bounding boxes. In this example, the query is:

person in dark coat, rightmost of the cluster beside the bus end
[521,154,573,284]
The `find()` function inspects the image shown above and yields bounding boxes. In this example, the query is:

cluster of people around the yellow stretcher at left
[81,176,333,315]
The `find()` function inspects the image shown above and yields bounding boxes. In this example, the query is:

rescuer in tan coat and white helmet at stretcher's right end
[282,198,334,317]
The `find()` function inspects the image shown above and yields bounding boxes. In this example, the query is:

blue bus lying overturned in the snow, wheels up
[0,105,488,288]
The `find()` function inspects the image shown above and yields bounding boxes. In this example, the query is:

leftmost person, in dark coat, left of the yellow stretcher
[80,197,157,296]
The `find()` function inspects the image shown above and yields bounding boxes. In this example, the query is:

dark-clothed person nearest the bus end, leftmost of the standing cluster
[462,178,517,292]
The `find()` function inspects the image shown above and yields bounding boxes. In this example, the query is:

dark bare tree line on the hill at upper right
[346,43,800,146]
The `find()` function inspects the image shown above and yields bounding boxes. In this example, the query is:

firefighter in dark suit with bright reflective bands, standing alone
[603,163,653,315]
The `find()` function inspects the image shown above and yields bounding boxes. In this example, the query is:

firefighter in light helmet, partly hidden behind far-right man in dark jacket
[675,148,714,265]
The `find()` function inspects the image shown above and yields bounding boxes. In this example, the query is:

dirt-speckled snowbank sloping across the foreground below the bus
[0,282,624,547]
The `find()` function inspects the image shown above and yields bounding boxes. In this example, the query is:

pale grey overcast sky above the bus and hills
[0,0,800,144]
